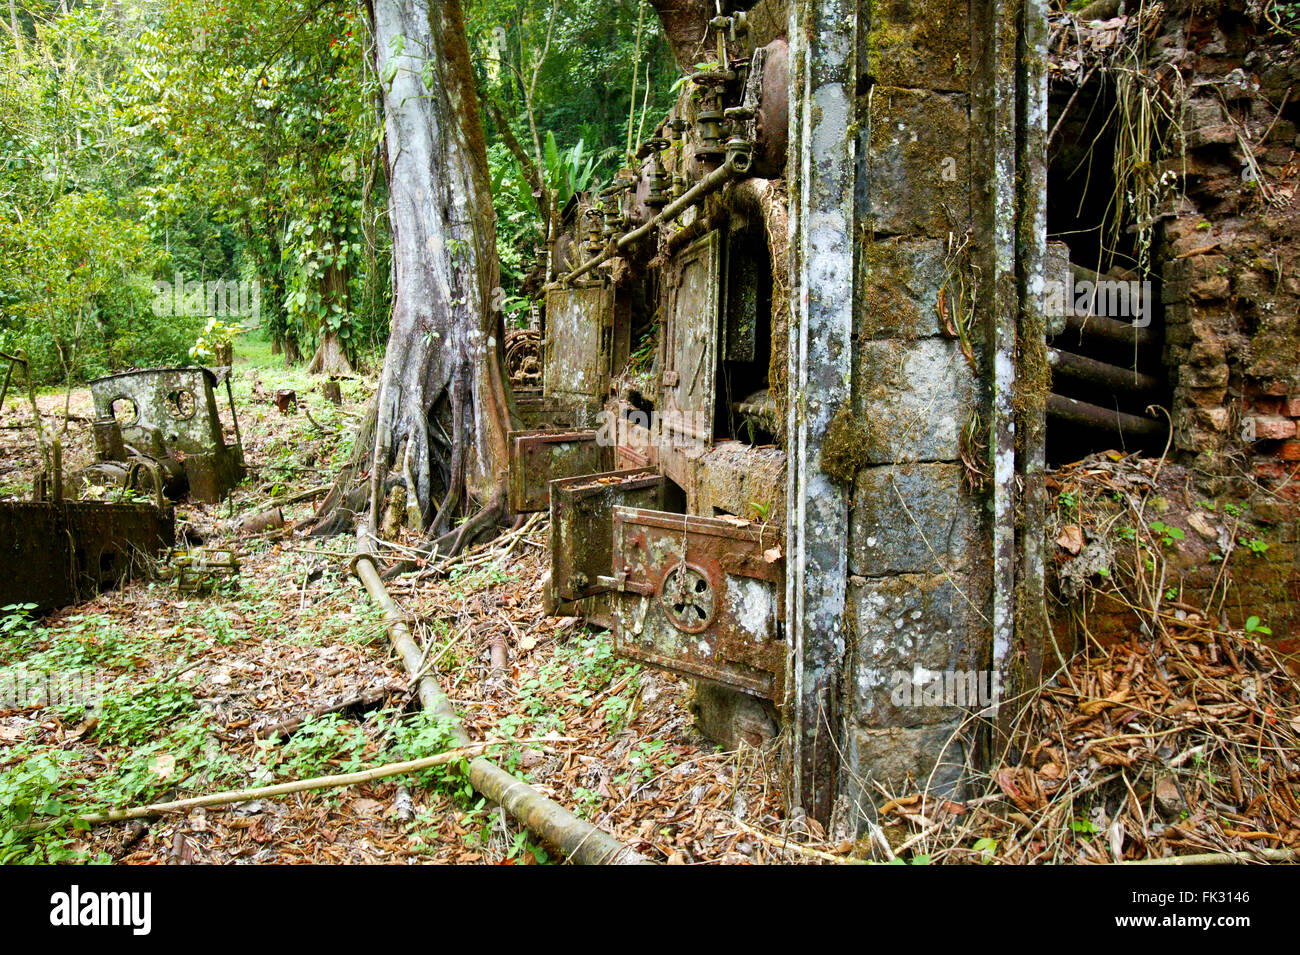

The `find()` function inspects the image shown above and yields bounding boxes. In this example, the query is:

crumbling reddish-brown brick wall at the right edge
[1056,1,1300,652]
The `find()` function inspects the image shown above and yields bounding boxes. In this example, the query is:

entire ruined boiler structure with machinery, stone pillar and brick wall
[510,0,1300,821]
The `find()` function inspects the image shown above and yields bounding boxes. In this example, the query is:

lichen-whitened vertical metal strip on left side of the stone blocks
[785,0,858,820]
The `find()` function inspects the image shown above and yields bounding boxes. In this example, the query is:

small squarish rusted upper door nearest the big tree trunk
[542,282,614,403]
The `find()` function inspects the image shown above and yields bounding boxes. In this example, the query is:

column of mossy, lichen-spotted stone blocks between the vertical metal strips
[840,0,991,820]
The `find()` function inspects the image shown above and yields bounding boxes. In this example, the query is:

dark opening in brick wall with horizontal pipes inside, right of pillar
[1047,78,1170,464]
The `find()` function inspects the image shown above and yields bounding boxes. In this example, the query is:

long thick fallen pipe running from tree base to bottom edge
[350,545,650,865]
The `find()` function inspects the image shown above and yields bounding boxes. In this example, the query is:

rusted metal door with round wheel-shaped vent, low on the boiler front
[605,507,787,702]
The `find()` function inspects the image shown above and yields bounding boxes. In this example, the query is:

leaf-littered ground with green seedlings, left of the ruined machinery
[0,342,854,864]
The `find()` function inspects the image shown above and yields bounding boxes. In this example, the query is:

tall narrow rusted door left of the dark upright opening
[662,230,722,450]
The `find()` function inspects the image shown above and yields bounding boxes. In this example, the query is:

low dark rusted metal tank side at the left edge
[0,502,176,611]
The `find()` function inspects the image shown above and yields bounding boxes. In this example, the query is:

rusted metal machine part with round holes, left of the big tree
[83,368,244,504]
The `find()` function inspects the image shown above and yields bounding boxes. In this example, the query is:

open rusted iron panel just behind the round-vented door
[551,468,664,600]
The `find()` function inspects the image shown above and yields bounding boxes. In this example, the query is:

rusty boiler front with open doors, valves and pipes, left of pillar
[508,14,789,703]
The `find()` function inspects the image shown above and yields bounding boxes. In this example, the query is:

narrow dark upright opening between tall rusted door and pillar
[714,217,777,446]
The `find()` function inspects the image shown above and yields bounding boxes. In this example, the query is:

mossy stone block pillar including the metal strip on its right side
[833,0,1045,825]
